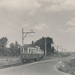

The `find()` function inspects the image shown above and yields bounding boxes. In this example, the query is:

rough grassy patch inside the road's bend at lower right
[57,58,75,75]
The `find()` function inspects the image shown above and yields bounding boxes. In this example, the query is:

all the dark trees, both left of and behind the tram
[0,37,54,56]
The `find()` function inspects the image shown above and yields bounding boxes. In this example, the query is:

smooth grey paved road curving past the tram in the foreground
[0,57,72,75]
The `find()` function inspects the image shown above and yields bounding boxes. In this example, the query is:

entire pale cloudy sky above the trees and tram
[0,0,75,51]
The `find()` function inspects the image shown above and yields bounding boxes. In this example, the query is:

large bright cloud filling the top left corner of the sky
[0,0,41,11]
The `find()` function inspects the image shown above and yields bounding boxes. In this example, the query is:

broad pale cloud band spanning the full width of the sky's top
[0,0,75,15]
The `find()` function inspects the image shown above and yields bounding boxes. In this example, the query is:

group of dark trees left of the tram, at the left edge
[0,37,20,56]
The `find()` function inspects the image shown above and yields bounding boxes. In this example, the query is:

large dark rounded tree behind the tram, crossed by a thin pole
[35,37,53,55]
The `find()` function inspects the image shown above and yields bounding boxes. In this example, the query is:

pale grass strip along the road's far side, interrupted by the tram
[0,53,70,69]
